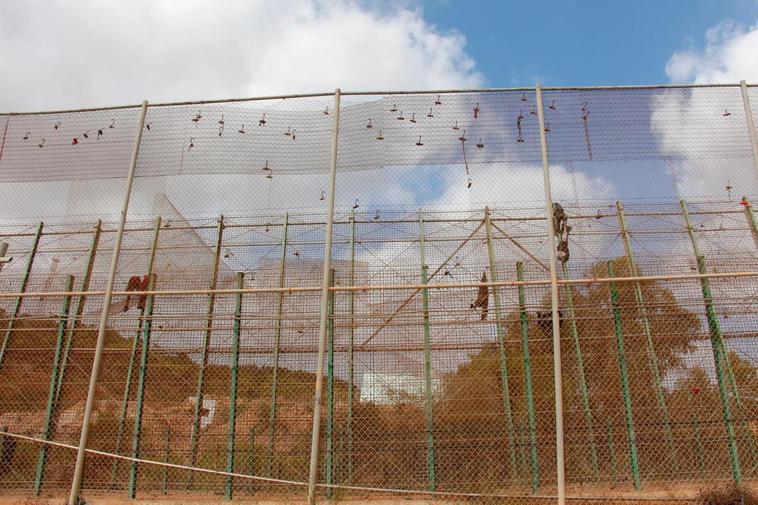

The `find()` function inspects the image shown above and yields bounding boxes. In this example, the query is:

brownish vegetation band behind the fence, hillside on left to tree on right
[0,261,758,496]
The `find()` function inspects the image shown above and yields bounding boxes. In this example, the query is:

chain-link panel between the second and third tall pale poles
[319,90,556,501]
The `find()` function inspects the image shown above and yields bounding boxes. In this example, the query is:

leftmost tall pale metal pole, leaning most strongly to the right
[68,100,147,505]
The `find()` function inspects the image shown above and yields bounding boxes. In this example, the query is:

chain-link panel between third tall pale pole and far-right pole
[544,86,758,493]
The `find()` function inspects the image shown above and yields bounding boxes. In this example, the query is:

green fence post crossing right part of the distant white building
[418,209,437,491]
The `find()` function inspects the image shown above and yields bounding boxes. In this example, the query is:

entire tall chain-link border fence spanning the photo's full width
[0,82,758,505]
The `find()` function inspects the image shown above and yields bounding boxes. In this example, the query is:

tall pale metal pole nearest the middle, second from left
[308,88,340,505]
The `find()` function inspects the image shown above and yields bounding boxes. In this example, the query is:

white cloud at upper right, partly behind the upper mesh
[650,20,758,197]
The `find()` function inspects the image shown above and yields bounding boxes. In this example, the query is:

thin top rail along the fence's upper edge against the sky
[0,83,758,116]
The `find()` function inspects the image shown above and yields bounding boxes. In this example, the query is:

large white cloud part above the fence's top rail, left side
[0,0,483,111]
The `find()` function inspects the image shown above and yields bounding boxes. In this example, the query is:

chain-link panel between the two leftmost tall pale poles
[88,95,333,496]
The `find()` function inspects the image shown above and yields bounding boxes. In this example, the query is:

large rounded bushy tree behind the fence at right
[438,258,703,482]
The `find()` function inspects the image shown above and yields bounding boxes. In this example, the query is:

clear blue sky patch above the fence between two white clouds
[423,0,758,87]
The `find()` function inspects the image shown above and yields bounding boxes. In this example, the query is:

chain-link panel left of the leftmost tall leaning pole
[0,103,137,494]
